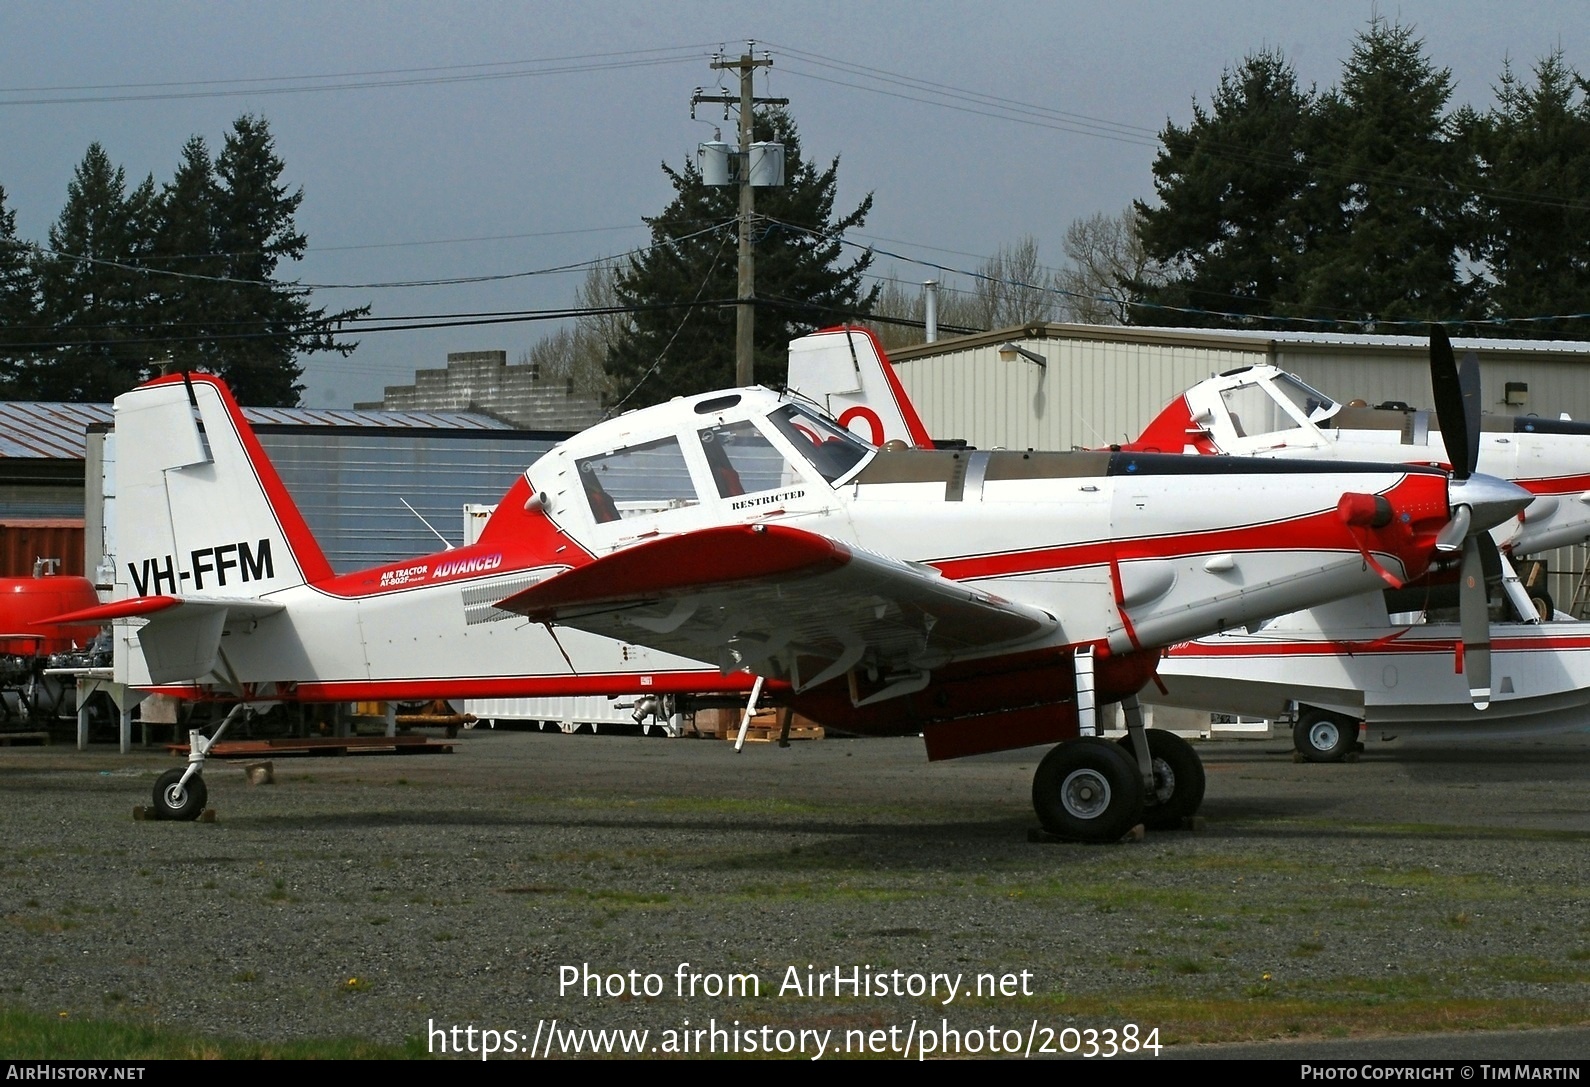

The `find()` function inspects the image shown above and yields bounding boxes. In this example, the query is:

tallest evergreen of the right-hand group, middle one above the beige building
[1299,19,1474,331]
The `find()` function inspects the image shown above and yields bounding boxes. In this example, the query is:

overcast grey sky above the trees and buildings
[0,0,1590,405]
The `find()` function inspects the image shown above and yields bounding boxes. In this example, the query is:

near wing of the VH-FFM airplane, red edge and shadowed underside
[498,524,1059,693]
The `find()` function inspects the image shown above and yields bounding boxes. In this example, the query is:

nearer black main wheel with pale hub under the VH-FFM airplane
[1032,736,1143,842]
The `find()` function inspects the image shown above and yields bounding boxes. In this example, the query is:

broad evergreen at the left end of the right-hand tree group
[1130,51,1323,326]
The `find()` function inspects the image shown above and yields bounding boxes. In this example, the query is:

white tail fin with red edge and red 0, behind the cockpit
[787,327,933,450]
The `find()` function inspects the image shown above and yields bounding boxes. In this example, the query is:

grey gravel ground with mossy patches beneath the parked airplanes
[0,731,1590,1055]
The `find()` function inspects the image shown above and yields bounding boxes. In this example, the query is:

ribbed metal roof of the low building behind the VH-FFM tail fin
[0,400,514,461]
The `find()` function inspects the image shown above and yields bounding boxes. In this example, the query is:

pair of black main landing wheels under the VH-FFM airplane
[1032,698,1204,842]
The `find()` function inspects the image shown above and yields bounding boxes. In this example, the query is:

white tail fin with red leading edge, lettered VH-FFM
[116,375,331,602]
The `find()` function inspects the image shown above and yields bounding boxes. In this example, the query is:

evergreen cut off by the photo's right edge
[1474,52,1590,335]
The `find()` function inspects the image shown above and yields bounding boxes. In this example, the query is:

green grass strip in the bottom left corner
[0,1009,425,1060]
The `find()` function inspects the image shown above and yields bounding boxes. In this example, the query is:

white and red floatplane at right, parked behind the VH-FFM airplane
[1124,327,1590,750]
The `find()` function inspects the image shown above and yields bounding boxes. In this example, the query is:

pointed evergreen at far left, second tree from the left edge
[32,143,156,402]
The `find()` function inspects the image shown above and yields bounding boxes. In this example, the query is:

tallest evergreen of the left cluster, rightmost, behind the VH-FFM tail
[208,114,360,407]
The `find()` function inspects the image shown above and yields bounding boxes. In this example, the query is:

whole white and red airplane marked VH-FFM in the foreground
[64,355,1528,841]
